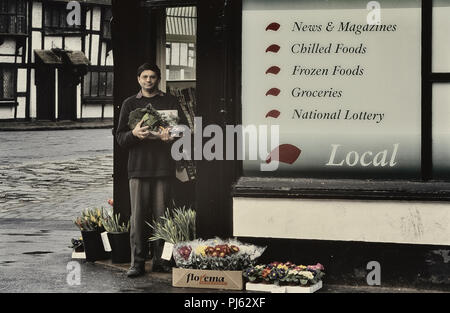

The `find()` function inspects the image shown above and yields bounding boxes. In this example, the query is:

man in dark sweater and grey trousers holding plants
[116,63,185,277]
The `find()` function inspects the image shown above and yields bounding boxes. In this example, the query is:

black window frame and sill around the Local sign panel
[231,0,450,202]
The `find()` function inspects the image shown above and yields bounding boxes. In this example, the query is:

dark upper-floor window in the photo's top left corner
[0,0,27,35]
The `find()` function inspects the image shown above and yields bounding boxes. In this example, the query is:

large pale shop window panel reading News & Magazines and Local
[242,0,422,180]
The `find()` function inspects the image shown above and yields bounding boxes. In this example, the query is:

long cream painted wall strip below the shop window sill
[233,198,450,245]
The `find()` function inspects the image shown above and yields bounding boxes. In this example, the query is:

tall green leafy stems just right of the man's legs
[146,207,196,244]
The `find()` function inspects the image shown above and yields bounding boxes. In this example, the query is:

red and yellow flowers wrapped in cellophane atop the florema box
[173,238,266,271]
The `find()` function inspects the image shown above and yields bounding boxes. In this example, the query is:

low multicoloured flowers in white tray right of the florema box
[243,262,325,286]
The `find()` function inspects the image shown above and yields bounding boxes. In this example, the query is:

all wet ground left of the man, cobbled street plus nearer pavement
[0,129,118,292]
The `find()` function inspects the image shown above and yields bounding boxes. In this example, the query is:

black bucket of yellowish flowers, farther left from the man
[74,208,109,262]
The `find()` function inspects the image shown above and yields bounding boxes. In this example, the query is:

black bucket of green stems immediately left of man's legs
[103,214,131,263]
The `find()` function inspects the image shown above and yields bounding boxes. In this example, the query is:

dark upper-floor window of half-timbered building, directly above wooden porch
[44,2,85,35]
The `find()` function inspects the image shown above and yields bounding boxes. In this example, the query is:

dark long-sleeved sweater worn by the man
[116,92,186,178]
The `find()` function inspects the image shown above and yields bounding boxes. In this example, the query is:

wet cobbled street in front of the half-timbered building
[0,129,113,220]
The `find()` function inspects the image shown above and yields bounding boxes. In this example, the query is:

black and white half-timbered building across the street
[0,0,113,121]
